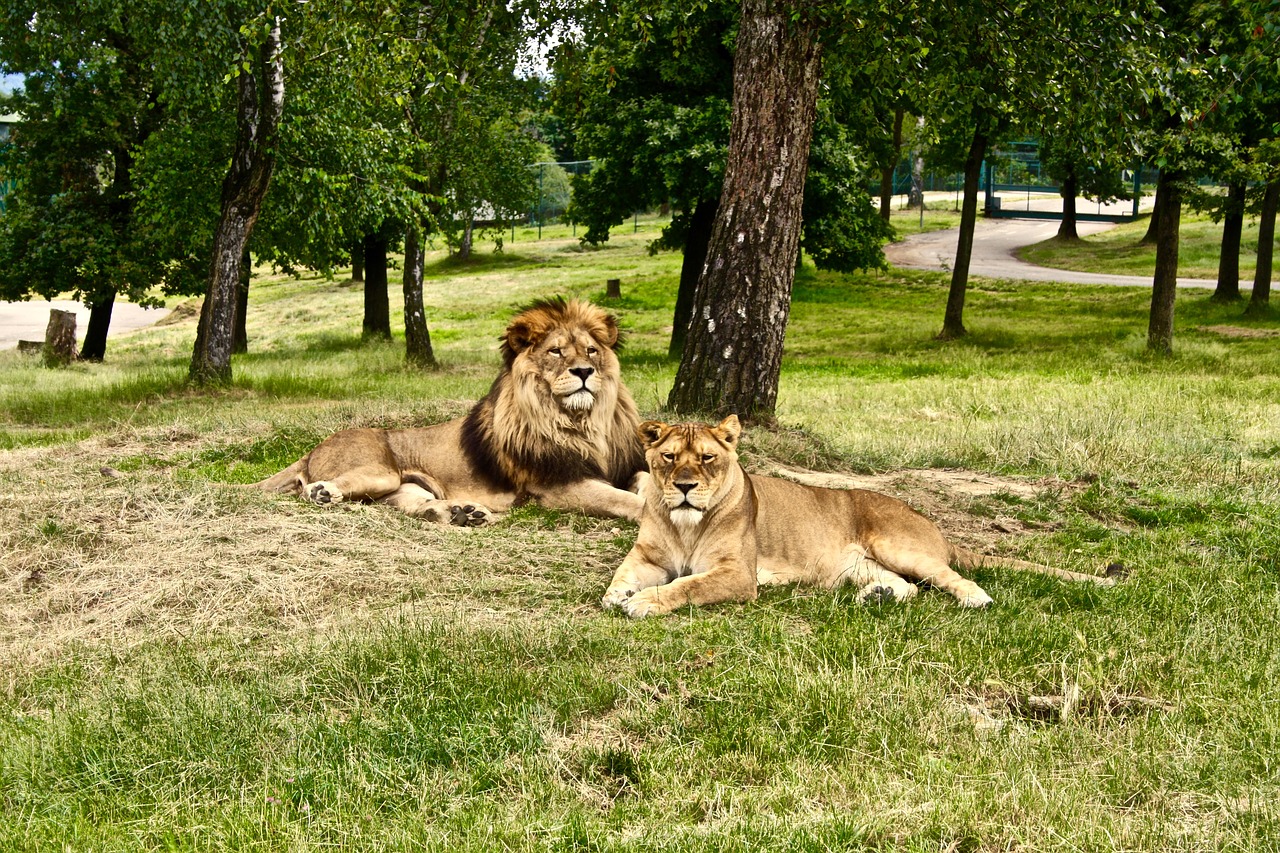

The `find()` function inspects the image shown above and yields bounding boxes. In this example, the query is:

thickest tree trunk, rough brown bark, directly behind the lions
[668,0,822,419]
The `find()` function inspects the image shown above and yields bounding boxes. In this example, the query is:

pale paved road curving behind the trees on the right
[884,219,1213,287]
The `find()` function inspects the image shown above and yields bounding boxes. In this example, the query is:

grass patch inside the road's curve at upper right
[1018,211,1274,279]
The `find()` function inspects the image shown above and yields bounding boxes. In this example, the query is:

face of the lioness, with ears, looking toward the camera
[639,415,742,526]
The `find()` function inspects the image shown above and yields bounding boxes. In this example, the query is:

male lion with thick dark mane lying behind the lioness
[255,298,644,526]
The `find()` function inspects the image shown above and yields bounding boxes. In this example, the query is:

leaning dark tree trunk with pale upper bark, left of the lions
[189,18,284,384]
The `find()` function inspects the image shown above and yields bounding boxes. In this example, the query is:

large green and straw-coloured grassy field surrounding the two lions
[0,220,1280,852]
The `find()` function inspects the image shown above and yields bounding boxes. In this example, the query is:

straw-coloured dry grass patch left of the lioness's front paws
[0,429,634,671]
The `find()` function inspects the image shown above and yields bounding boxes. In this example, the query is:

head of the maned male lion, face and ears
[503,301,618,414]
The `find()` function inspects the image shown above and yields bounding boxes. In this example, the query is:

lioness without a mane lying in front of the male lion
[603,415,1115,617]
